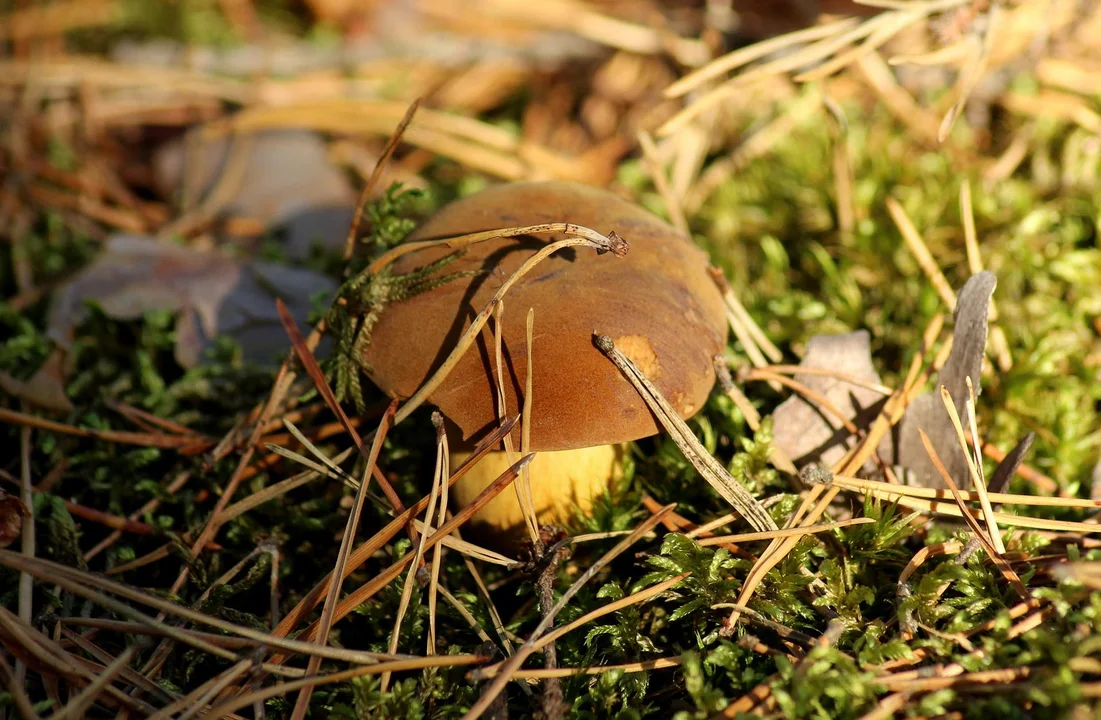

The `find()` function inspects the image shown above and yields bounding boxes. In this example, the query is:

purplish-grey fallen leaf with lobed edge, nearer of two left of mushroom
[47,236,336,368]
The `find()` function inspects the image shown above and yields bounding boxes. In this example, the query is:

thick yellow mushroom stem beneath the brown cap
[450,445,625,534]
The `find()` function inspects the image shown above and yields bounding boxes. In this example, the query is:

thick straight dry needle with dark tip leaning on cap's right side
[593,334,776,532]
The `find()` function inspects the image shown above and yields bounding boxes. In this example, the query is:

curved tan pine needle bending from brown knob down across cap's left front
[394,230,629,424]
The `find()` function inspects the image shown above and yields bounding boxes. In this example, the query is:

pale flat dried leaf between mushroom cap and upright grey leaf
[773,330,884,467]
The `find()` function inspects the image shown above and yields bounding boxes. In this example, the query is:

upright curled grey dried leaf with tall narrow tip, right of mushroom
[896,272,998,489]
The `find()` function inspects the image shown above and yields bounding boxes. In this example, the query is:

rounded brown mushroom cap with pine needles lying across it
[366,183,727,450]
